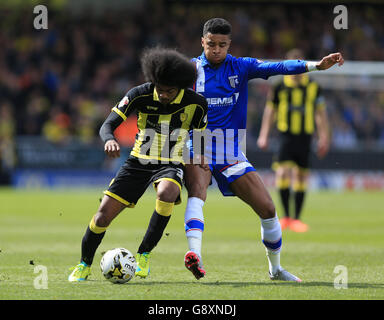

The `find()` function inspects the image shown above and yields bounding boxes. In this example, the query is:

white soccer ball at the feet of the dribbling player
[100,248,136,283]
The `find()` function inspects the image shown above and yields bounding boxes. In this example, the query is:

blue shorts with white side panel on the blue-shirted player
[209,160,256,197]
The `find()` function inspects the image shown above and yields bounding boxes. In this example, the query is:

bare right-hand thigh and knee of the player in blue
[230,171,276,219]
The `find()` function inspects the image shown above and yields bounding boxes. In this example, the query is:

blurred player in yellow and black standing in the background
[257,49,330,232]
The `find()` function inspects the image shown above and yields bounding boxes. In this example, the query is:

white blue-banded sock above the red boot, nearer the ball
[184,197,204,259]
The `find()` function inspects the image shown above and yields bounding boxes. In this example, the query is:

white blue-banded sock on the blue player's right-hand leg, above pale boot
[260,215,282,274]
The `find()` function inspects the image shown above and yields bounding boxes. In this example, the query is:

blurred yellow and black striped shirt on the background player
[267,75,325,136]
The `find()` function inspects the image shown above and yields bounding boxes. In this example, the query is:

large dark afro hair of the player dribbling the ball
[141,47,197,89]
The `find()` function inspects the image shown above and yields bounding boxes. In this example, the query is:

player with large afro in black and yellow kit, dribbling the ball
[68,48,207,282]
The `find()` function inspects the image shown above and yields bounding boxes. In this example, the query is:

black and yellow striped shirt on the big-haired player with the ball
[112,83,208,163]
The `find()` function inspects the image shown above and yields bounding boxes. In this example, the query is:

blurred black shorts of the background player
[273,135,311,169]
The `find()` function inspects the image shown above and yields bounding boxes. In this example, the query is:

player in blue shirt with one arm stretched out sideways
[184,18,343,281]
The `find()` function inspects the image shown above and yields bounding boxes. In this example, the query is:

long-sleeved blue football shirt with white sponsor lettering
[192,52,307,163]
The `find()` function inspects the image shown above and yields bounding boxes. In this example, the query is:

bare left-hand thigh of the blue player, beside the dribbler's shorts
[185,164,212,201]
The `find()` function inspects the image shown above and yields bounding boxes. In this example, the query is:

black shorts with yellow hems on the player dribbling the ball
[104,156,184,208]
